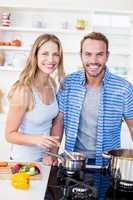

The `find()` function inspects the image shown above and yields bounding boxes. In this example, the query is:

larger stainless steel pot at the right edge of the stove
[103,149,133,183]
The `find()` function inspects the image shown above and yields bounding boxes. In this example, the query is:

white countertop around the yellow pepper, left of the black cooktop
[0,165,51,200]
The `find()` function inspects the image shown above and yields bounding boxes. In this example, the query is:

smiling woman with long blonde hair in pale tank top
[5,34,64,161]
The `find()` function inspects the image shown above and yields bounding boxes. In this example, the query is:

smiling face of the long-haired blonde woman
[37,41,60,74]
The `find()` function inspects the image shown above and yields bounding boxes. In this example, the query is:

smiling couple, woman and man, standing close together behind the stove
[5,32,133,165]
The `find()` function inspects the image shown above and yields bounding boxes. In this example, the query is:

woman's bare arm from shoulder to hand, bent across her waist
[5,89,59,148]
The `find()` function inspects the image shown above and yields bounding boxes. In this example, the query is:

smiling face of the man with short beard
[81,39,108,78]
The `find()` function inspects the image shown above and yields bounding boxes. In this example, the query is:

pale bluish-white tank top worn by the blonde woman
[11,84,58,162]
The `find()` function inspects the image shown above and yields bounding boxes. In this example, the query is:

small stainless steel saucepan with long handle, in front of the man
[46,151,85,172]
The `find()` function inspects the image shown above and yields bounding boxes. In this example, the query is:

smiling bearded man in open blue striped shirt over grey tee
[53,32,133,165]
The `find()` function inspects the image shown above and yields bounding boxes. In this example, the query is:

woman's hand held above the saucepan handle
[35,135,60,149]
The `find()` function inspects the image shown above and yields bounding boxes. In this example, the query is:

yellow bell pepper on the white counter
[11,172,30,190]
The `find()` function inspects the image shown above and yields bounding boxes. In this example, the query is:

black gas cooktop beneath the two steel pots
[44,166,133,200]
